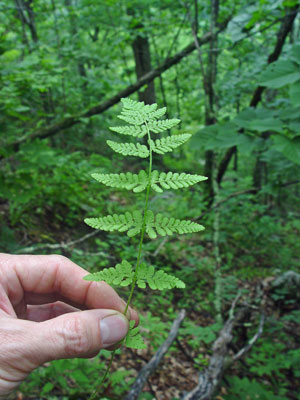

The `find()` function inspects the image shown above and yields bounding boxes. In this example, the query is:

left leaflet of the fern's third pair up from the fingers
[92,170,148,193]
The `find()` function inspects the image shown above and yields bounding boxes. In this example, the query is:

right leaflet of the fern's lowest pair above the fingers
[137,263,185,290]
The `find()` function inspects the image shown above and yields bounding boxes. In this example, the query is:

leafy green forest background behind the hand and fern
[0,0,300,400]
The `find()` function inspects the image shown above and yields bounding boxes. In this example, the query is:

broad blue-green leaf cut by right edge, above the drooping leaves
[260,60,300,89]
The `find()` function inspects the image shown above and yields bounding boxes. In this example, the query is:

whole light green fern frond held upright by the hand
[84,98,207,394]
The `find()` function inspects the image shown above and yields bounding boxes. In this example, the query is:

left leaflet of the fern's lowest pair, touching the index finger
[83,260,134,286]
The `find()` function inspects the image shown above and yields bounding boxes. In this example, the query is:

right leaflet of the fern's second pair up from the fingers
[146,210,204,239]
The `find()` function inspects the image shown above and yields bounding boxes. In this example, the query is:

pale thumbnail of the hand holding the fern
[100,314,129,347]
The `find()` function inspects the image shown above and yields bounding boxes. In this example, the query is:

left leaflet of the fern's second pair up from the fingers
[84,211,143,237]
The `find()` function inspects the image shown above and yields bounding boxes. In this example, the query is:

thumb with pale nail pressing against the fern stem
[38,309,129,364]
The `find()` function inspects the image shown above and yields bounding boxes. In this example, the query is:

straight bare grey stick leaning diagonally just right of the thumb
[124,310,185,400]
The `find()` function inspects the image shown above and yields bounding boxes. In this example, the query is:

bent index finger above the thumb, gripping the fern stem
[0,254,138,320]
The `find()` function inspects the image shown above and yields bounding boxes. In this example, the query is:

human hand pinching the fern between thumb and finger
[0,254,138,397]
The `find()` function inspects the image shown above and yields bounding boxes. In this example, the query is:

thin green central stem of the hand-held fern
[124,121,152,315]
